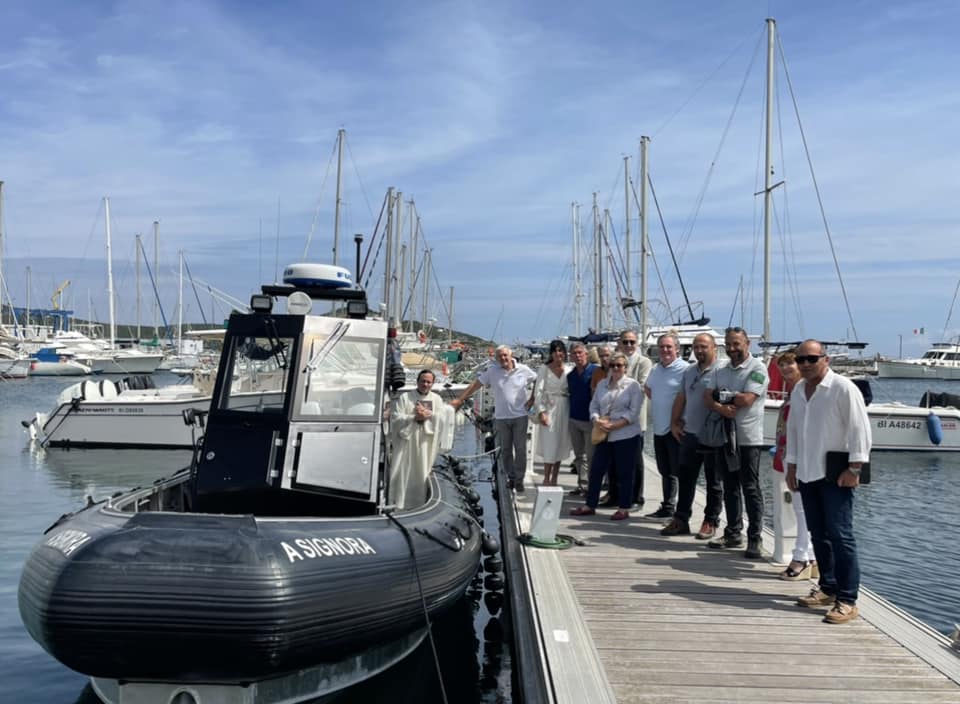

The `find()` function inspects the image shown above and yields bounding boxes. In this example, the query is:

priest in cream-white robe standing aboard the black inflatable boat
[390,369,454,509]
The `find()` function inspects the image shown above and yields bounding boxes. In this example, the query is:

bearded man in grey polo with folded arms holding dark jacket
[703,327,769,560]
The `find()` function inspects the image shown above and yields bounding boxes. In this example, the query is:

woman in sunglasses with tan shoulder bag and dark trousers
[570,352,643,521]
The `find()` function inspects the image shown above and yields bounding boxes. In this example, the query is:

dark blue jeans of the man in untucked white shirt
[800,479,860,604]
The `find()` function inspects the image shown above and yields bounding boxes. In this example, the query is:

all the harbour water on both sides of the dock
[0,375,960,704]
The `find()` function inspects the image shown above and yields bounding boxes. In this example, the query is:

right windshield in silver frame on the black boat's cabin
[297,330,384,419]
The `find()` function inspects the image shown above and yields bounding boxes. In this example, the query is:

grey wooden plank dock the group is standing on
[501,458,960,704]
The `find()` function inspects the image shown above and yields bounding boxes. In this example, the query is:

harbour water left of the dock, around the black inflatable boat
[0,374,511,704]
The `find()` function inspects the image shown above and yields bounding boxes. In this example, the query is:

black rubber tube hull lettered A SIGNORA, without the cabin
[19,473,481,682]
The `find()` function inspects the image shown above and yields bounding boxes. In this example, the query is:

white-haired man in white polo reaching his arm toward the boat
[450,345,537,493]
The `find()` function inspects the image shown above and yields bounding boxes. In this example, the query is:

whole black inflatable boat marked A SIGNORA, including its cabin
[19,272,490,702]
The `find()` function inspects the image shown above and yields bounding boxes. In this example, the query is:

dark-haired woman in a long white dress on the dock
[531,340,571,486]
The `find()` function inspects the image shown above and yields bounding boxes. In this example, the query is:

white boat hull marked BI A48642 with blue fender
[763,399,960,452]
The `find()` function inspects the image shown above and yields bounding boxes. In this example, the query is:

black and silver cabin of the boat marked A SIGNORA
[192,282,402,516]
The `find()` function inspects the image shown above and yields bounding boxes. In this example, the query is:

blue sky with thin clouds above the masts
[0,0,960,354]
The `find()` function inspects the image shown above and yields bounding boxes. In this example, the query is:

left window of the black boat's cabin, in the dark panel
[220,336,294,413]
